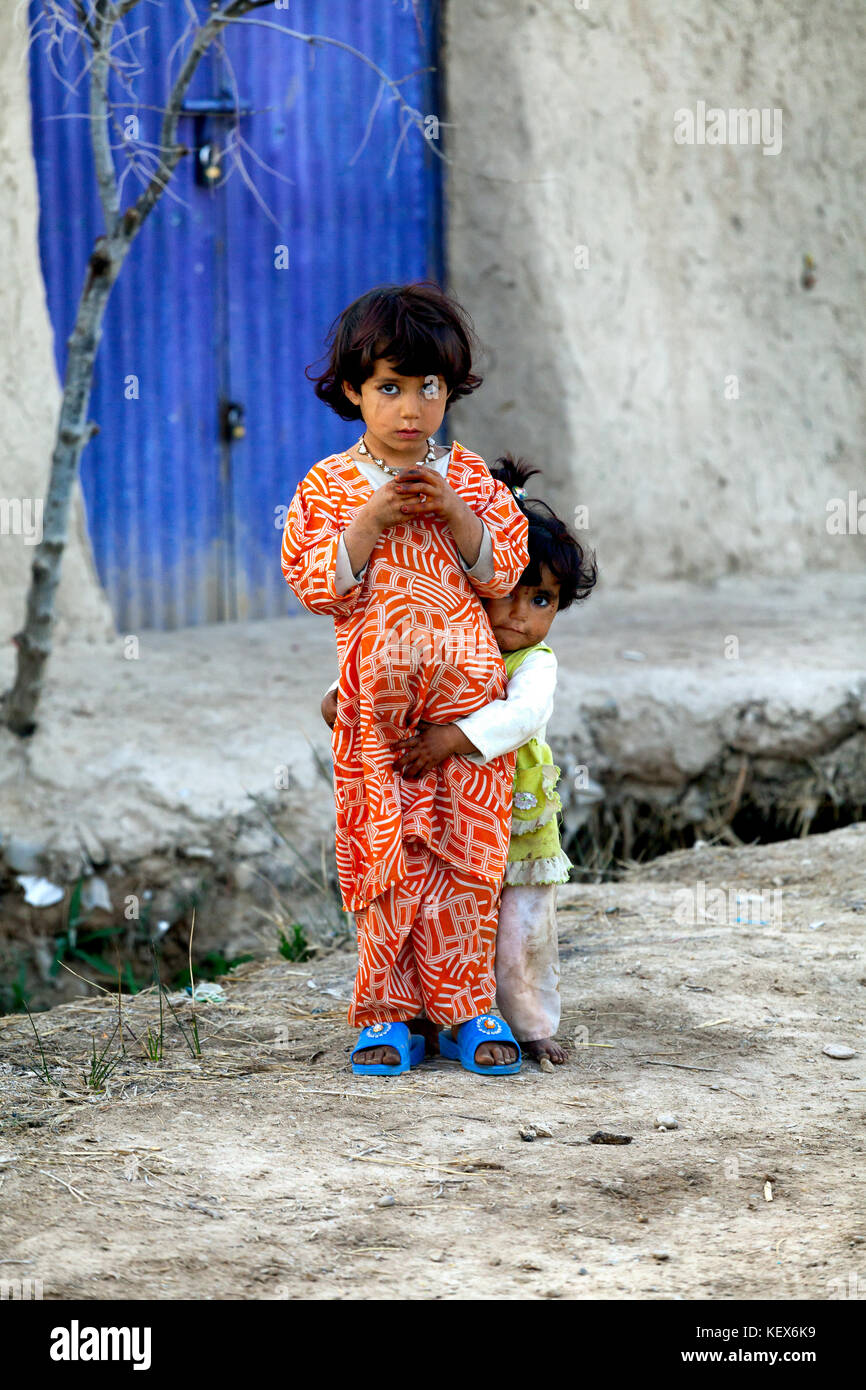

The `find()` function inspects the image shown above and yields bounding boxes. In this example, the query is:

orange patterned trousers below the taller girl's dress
[349,841,499,1029]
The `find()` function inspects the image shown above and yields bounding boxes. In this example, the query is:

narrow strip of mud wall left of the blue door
[0,6,113,642]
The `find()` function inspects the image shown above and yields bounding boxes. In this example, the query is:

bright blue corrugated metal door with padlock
[31,0,442,631]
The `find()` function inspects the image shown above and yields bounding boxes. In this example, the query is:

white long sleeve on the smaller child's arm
[455,652,556,763]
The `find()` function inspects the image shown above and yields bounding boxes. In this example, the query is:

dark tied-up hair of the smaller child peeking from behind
[491,453,598,612]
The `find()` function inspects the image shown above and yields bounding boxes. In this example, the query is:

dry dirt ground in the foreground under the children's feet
[0,823,866,1300]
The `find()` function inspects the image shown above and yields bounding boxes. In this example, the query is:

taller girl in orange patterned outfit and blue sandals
[282,285,528,1074]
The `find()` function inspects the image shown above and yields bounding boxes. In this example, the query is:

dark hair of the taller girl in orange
[306,281,481,420]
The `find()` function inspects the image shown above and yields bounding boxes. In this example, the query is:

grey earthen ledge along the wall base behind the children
[0,573,866,876]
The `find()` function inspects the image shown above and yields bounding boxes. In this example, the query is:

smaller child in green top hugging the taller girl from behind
[398,457,596,1063]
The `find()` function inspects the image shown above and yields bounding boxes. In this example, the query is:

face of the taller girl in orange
[343,357,448,463]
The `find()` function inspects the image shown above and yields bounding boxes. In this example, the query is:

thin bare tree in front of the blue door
[4,0,443,735]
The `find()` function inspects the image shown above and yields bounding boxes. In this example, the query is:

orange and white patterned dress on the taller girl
[282,443,528,1017]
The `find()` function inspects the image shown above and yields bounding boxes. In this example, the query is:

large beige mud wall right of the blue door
[443,0,866,585]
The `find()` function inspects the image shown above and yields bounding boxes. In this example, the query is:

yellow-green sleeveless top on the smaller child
[503,642,571,885]
